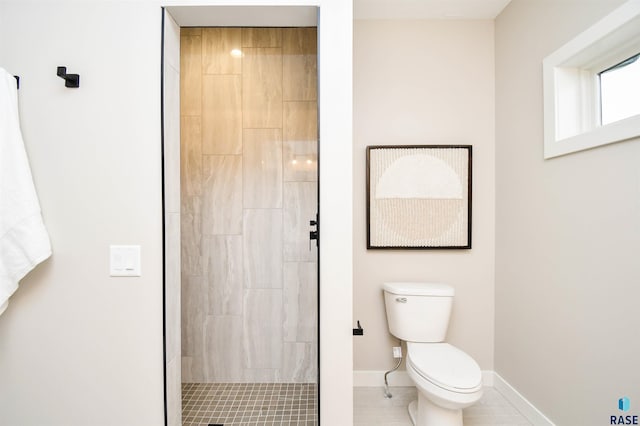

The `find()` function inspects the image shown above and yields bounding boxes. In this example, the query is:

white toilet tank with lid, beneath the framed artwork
[383,282,455,343]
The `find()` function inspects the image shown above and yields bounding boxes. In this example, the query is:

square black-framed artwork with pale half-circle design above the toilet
[367,145,472,249]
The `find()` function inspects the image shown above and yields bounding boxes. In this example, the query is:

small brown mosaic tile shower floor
[182,383,318,426]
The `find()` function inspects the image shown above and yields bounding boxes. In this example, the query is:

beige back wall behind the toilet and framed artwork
[353,21,495,370]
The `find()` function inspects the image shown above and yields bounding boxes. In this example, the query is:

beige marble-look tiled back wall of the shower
[180,28,317,383]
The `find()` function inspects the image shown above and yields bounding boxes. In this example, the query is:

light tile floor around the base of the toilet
[353,387,531,426]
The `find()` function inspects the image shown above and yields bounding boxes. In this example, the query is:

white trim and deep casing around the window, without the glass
[543,0,640,159]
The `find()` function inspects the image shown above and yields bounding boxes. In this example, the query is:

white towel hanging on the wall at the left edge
[0,68,51,315]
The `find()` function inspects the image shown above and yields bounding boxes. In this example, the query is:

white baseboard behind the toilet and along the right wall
[353,370,555,426]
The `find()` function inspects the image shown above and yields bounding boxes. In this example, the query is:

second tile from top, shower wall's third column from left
[242,48,282,129]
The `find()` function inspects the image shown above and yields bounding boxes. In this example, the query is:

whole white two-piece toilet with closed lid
[383,282,482,426]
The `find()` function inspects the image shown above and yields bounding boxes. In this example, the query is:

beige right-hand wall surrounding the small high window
[495,0,640,425]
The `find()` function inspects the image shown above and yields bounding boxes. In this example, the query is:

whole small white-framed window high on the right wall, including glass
[543,0,640,158]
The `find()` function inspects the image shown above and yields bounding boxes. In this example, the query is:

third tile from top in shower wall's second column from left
[202,155,242,235]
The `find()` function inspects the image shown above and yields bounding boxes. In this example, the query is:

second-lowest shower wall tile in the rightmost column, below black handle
[283,262,318,343]
